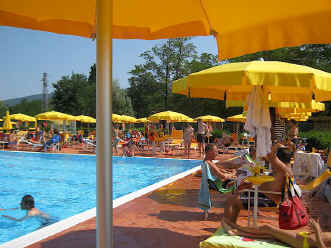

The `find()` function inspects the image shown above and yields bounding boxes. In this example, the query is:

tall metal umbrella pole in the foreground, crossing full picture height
[96,0,113,248]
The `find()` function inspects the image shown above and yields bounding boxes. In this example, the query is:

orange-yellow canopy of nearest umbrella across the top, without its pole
[0,0,331,58]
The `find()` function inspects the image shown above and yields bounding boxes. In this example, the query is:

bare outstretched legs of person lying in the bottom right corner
[222,218,331,248]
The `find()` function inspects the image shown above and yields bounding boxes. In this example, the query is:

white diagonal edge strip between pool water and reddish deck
[0,164,201,248]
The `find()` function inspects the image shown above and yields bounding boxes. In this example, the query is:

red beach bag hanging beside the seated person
[278,178,309,230]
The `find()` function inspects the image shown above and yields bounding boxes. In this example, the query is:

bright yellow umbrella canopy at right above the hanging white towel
[172,61,331,106]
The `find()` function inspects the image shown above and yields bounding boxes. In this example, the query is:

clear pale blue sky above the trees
[0,26,217,100]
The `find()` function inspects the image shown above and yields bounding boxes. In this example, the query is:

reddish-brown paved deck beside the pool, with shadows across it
[1,146,331,248]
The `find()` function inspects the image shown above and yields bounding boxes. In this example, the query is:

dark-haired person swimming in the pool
[2,195,50,225]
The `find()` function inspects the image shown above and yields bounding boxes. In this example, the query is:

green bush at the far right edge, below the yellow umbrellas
[299,130,331,149]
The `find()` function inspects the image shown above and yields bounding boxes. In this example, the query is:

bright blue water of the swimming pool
[0,151,200,244]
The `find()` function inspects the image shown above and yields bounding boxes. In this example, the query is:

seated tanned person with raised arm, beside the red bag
[224,146,293,223]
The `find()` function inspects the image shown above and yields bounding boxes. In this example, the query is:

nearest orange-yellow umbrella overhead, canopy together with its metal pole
[0,0,331,247]
